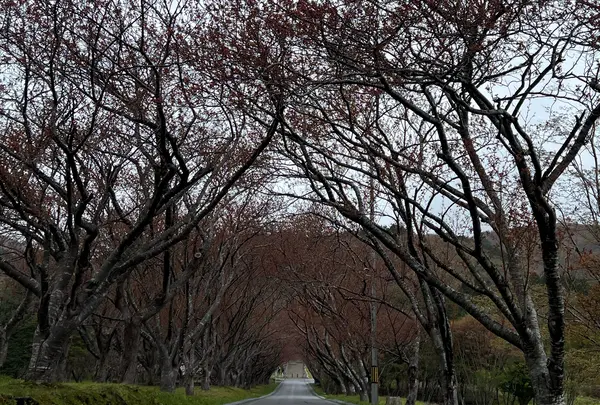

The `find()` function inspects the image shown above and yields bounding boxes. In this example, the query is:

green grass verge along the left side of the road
[0,376,277,405]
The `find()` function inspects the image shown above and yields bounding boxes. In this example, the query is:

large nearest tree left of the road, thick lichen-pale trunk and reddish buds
[0,0,281,381]
